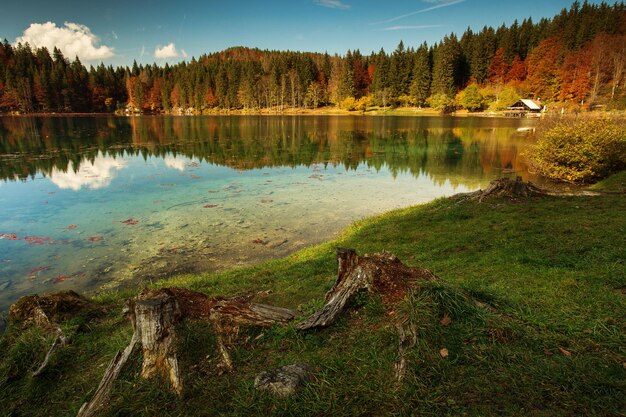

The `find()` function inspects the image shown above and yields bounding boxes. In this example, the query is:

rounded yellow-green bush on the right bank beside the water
[529,119,626,182]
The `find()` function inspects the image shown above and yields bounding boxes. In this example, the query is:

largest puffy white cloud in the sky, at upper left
[15,22,114,61]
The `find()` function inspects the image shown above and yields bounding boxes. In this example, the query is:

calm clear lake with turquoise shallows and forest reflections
[0,116,535,310]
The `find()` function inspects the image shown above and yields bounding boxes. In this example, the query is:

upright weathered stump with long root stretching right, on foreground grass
[78,288,296,417]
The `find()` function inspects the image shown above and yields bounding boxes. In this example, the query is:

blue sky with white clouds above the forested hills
[0,0,599,65]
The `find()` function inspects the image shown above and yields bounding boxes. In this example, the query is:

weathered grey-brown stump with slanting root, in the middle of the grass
[298,249,435,330]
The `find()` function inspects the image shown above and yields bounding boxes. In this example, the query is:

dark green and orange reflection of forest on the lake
[0,116,528,186]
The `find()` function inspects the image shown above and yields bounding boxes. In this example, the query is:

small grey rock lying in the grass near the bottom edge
[254,363,311,397]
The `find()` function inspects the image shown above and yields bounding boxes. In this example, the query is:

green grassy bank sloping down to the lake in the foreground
[0,173,626,416]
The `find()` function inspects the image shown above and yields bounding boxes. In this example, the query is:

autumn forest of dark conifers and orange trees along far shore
[0,2,626,114]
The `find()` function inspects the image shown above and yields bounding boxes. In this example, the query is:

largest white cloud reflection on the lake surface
[50,153,126,191]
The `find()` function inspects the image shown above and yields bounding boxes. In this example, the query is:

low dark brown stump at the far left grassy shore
[9,291,103,377]
